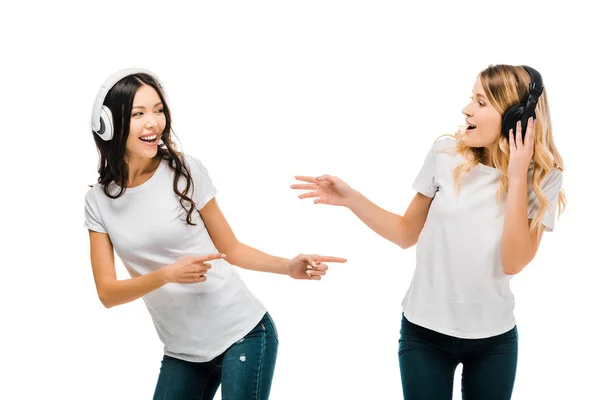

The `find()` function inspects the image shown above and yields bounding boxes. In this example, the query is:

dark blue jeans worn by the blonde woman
[398,315,519,400]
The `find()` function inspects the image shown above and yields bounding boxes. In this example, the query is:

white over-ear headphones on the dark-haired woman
[92,68,166,141]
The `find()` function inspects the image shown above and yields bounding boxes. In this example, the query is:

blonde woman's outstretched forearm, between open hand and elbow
[347,191,415,249]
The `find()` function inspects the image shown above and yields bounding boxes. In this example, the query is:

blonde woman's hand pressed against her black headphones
[508,117,536,181]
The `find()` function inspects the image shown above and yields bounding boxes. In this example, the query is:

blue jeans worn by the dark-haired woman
[154,313,279,400]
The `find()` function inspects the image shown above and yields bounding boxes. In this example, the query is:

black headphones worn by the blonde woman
[502,65,544,139]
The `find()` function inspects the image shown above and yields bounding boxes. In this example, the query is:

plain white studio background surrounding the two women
[0,0,600,400]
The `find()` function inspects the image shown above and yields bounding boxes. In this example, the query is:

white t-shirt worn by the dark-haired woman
[84,155,266,362]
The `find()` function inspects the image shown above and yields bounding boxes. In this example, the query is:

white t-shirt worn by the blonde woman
[402,138,562,339]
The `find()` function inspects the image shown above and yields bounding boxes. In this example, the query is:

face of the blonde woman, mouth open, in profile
[462,78,502,148]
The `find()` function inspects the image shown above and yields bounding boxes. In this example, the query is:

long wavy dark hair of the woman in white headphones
[93,73,196,225]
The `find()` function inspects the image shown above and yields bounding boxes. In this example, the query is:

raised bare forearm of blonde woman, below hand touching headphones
[502,179,533,275]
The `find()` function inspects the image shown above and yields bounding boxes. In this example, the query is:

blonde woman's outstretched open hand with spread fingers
[290,175,355,207]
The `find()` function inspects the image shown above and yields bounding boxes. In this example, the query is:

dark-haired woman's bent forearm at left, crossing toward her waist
[98,269,167,308]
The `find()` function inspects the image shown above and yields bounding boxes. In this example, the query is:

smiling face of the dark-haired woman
[125,85,166,163]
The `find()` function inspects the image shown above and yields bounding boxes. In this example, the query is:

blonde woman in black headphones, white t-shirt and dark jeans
[292,65,566,400]
